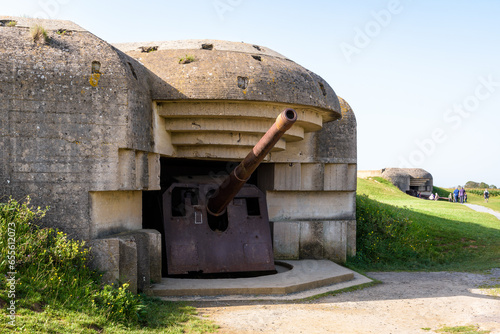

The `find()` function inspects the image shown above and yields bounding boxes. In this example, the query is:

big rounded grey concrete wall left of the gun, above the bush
[0,19,159,239]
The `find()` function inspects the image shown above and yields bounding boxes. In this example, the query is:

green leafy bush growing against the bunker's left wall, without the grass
[0,197,142,324]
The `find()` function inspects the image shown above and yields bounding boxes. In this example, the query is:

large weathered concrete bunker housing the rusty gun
[0,17,356,290]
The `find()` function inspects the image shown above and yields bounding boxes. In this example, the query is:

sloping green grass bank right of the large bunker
[347,178,500,272]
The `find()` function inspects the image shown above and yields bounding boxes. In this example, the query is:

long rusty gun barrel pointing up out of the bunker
[207,108,297,216]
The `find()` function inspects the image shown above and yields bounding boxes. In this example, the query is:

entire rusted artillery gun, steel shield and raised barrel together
[163,109,297,275]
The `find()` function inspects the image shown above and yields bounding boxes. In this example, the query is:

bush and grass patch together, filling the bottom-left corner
[0,198,215,333]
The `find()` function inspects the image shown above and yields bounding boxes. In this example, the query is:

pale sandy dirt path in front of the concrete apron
[194,268,500,334]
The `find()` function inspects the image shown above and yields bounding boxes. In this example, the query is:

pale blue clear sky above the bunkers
[0,0,500,187]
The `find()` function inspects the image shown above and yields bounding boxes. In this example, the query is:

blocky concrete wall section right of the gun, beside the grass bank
[259,98,357,263]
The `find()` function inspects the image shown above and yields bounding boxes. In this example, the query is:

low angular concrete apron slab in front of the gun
[149,260,372,301]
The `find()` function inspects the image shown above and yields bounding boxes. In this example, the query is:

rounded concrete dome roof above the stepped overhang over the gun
[115,40,341,121]
